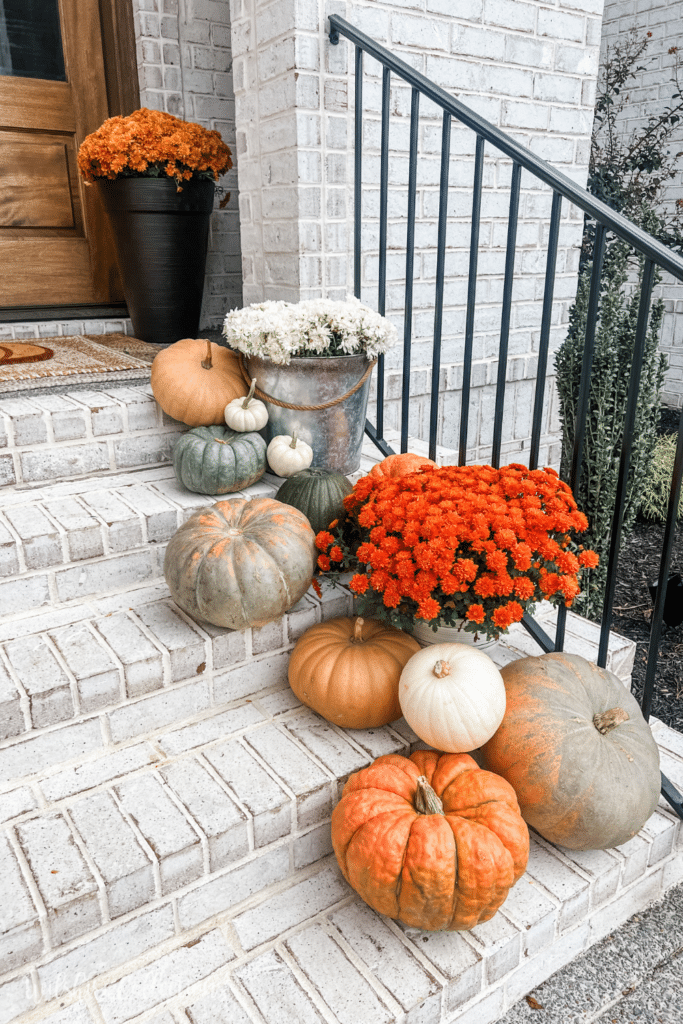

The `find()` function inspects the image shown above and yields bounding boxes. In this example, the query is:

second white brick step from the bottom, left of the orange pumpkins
[0,651,417,983]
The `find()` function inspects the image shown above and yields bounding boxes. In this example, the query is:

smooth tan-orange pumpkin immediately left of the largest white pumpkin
[289,617,420,729]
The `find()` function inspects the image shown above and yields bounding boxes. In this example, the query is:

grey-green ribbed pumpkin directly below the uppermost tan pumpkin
[173,426,266,495]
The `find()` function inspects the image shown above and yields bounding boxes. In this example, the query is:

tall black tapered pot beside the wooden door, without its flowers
[97,178,214,345]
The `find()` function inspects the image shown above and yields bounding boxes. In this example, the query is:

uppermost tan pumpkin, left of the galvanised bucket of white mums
[152,338,247,427]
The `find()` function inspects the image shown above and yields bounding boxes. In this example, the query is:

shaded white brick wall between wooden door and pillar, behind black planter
[132,0,242,329]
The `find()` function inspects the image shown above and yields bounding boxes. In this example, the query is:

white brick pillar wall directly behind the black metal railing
[231,0,601,462]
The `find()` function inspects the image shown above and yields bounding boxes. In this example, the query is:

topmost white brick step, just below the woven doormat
[0,384,187,486]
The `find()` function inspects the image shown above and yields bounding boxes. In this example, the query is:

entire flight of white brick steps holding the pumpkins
[0,388,683,1024]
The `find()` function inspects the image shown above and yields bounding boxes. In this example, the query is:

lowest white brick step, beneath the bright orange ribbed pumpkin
[0,798,683,1024]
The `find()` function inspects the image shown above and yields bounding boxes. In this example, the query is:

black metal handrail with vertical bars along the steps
[329,14,683,816]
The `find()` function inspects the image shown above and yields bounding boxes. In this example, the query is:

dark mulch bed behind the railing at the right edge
[611,410,683,732]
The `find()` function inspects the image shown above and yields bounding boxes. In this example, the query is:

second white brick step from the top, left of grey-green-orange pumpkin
[0,465,282,623]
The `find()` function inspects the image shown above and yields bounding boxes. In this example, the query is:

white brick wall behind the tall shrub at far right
[601,0,683,409]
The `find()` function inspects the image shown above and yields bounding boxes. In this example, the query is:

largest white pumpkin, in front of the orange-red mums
[398,643,505,754]
